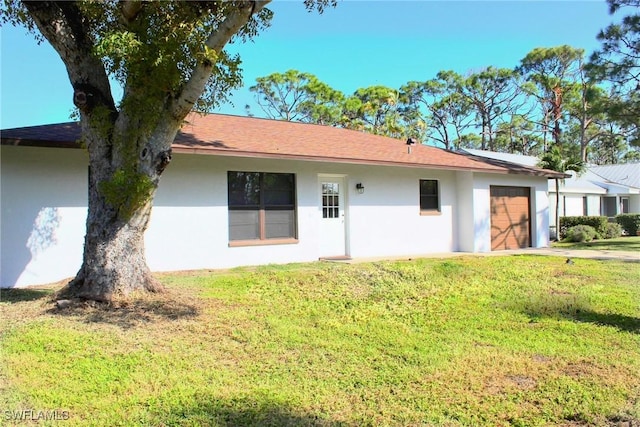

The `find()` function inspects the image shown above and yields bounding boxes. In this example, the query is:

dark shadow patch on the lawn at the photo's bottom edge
[165,398,348,427]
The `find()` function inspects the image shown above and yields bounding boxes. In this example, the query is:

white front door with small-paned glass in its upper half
[319,177,346,257]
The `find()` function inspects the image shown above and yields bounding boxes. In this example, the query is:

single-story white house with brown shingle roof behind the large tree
[0,114,564,287]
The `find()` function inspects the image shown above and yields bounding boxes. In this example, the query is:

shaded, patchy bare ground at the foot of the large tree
[48,292,200,329]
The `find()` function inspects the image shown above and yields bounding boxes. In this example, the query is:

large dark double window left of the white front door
[227,171,298,246]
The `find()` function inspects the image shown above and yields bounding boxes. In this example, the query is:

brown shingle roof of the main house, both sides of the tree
[1,114,563,178]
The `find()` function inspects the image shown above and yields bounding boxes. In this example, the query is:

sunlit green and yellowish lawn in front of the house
[0,255,640,426]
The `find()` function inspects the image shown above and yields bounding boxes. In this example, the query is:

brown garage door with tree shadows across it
[491,186,531,251]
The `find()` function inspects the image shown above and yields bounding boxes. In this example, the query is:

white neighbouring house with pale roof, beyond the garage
[464,149,640,232]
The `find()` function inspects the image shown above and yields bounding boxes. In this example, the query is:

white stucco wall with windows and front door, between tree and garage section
[146,155,456,270]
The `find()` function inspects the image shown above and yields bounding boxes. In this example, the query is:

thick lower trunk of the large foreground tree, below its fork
[62,116,178,301]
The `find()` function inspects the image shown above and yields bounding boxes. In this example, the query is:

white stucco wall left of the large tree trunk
[0,146,88,287]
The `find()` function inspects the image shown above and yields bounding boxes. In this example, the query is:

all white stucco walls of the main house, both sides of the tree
[0,146,548,287]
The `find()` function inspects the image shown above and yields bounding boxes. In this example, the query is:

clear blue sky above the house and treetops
[0,0,618,129]
